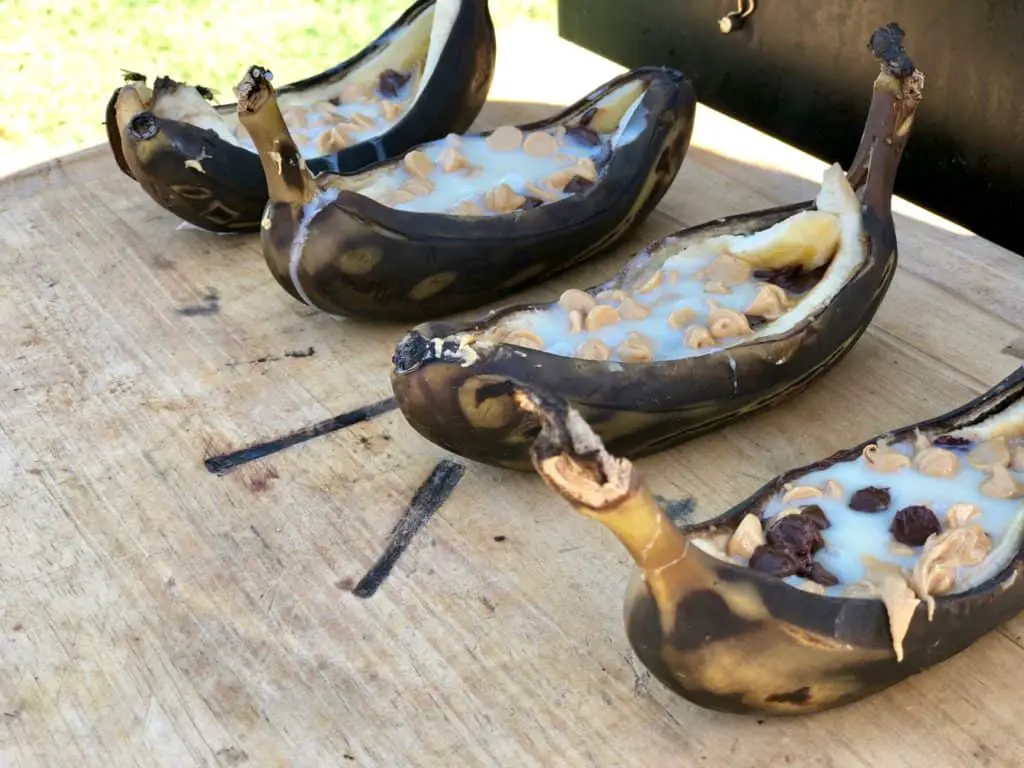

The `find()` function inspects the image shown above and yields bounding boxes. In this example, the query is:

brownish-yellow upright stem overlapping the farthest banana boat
[236,67,317,205]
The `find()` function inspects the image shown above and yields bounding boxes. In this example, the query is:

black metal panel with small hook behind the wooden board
[558,0,1024,259]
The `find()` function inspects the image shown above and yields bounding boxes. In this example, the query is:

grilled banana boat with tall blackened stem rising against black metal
[391,25,924,470]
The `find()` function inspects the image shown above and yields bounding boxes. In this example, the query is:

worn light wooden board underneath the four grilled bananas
[0,24,1024,768]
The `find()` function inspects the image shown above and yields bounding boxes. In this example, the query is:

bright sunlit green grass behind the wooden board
[0,0,556,167]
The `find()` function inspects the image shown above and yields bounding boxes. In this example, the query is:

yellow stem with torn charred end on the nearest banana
[513,388,692,578]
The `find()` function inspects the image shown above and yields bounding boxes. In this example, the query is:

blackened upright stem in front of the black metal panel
[847,23,925,198]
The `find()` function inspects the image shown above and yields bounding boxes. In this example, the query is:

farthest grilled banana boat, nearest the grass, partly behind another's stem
[106,0,496,232]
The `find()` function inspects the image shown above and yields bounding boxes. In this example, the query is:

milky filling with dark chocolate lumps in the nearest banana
[696,406,1024,659]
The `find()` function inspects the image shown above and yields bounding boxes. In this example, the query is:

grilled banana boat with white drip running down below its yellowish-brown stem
[238,60,695,323]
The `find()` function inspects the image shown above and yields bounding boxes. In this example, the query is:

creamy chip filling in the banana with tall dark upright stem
[475,159,865,362]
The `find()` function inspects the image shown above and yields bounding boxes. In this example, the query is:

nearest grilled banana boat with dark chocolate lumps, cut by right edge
[513,367,1024,715]
